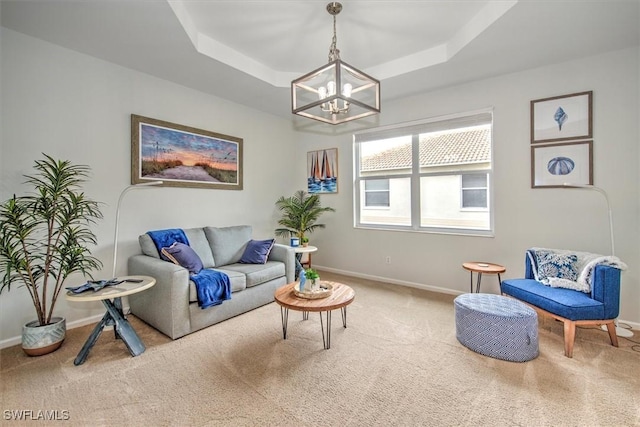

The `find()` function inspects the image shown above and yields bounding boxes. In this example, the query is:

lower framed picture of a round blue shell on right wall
[531,141,593,188]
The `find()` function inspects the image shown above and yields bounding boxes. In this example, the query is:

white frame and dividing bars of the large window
[353,108,494,237]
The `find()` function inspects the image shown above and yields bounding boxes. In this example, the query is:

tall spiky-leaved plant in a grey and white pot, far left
[0,154,102,356]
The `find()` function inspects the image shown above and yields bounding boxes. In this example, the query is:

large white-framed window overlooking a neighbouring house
[354,110,493,235]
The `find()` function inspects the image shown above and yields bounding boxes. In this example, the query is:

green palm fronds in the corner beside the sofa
[275,190,336,242]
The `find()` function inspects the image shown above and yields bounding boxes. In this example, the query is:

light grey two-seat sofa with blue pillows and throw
[128,225,295,339]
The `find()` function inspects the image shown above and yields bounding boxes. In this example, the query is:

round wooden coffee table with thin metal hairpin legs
[274,281,356,350]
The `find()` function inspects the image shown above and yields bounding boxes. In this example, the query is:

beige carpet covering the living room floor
[0,273,640,426]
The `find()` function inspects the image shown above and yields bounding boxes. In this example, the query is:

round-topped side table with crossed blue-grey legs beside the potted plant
[65,276,156,366]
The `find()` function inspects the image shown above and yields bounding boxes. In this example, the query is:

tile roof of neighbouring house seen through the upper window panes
[361,126,491,171]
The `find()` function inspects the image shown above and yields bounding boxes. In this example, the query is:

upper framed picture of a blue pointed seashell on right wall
[531,91,593,144]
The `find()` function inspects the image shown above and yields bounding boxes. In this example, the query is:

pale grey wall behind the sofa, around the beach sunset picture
[0,28,298,346]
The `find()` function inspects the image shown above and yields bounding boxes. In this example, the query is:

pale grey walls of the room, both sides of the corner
[0,28,640,347]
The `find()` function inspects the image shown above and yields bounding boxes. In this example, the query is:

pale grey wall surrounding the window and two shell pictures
[305,48,640,327]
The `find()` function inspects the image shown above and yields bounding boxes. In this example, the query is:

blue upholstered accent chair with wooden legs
[500,251,620,357]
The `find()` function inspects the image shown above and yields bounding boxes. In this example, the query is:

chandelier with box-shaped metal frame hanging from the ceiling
[291,2,380,125]
